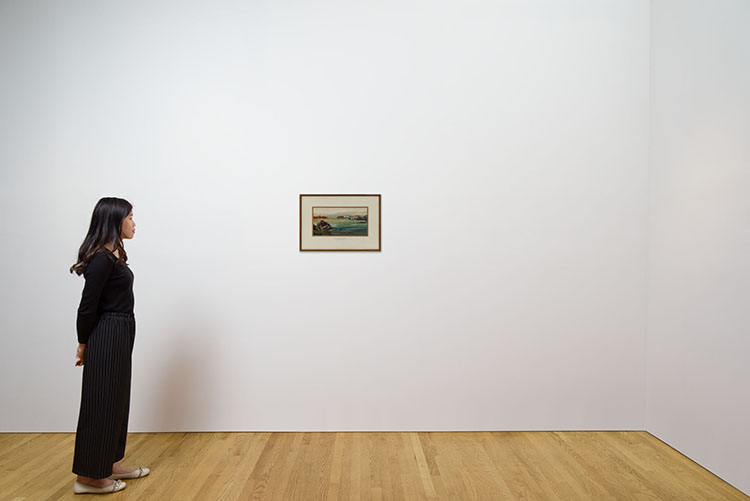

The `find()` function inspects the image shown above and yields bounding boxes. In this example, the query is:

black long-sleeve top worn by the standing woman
[76,249,135,344]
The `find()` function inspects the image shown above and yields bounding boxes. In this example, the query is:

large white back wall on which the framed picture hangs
[0,0,649,431]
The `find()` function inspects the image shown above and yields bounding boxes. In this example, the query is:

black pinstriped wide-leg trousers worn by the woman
[73,312,135,478]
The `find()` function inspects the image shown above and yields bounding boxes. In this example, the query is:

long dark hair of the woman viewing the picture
[70,197,133,275]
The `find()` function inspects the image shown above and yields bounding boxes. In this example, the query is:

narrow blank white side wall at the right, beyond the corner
[646,0,750,493]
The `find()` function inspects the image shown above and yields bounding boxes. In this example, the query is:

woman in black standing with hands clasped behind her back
[70,198,149,494]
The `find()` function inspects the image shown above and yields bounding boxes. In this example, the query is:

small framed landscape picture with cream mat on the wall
[299,194,380,251]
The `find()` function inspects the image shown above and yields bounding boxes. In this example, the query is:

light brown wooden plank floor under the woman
[0,432,748,501]
